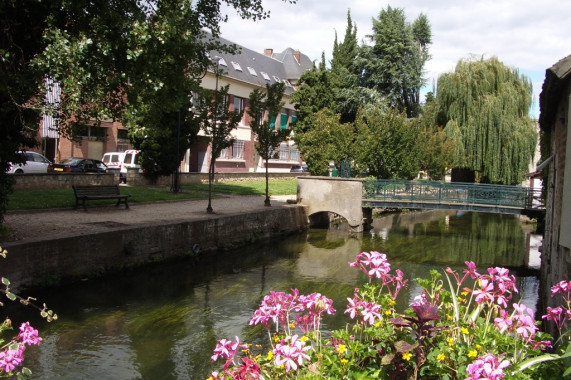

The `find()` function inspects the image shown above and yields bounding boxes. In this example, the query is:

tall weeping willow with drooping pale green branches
[436,57,537,184]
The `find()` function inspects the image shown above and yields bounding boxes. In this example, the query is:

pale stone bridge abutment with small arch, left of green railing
[297,176,363,232]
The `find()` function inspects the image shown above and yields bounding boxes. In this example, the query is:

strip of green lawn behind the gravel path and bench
[6,179,297,211]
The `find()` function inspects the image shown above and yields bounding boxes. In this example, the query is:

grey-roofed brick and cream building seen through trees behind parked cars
[39,39,313,173]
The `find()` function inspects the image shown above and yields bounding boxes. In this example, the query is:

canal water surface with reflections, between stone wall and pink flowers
[15,211,539,379]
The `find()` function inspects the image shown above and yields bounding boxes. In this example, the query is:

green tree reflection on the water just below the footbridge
[363,212,526,267]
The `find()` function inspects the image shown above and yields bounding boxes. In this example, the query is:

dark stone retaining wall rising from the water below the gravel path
[2,205,307,290]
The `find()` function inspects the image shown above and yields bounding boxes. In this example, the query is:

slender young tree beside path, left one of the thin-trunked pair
[198,83,242,213]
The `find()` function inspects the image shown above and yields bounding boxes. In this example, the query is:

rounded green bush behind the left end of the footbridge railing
[355,108,421,179]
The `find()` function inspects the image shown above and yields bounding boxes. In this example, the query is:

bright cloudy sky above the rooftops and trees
[221,0,571,118]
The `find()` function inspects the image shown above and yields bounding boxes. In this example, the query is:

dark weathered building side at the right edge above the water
[539,55,571,332]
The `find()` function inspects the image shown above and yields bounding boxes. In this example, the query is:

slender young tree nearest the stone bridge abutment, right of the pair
[248,83,291,206]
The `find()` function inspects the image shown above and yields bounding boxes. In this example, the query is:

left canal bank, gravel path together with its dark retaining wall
[0,196,308,290]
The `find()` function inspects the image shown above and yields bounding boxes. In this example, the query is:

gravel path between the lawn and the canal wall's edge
[0,194,296,246]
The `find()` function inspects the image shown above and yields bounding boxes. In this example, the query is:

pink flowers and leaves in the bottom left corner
[0,247,57,379]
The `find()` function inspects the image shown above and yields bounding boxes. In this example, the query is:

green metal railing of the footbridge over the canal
[363,180,543,209]
